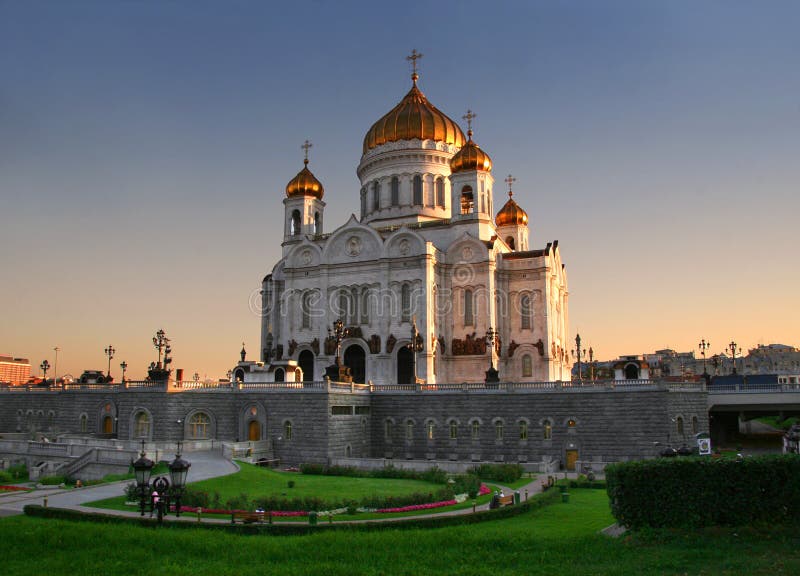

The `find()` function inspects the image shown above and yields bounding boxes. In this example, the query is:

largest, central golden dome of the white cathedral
[364,73,466,154]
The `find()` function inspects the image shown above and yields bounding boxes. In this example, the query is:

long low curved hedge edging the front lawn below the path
[18,490,561,536]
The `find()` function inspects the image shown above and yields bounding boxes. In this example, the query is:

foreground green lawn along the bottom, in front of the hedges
[6,489,800,576]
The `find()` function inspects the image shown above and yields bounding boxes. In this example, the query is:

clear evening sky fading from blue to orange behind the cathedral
[0,0,800,377]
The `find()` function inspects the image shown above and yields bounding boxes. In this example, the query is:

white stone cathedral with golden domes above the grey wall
[248,52,571,386]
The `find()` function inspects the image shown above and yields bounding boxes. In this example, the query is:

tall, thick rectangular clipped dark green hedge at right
[605,454,800,529]
